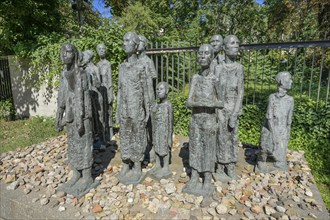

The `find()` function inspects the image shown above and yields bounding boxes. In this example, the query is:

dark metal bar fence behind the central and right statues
[147,41,330,107]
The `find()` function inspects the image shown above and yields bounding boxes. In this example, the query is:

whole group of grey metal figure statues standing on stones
[56,32,293,197]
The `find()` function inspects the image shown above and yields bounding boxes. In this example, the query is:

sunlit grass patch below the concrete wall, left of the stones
[0,116,63,153]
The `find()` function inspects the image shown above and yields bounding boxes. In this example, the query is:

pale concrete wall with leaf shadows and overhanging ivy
[8,56,57,118]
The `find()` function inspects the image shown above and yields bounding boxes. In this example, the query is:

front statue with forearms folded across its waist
[183,44,223,196]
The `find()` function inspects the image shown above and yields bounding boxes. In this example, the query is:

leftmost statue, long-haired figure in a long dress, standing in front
[56,44,97,198]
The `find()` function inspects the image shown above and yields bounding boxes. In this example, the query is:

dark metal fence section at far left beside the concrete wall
[0,57,13,101]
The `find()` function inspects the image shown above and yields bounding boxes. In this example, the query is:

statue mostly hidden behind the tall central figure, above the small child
[138,35,157,161]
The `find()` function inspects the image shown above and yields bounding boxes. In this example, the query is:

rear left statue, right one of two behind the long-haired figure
[96,43,114,146]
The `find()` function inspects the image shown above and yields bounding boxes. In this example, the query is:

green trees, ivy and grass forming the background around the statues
[0,0,330,209]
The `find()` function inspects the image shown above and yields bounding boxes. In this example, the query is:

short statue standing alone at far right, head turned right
[256,72,294,172]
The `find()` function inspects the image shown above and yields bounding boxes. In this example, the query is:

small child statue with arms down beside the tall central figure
[149,82,173,179]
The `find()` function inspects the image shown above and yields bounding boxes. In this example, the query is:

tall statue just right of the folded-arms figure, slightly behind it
[214,35,244,181]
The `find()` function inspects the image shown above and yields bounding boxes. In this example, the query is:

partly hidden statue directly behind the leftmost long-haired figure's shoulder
[81,50,104,147]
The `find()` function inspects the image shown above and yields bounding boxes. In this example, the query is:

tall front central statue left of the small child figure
[116,32,149,184]
